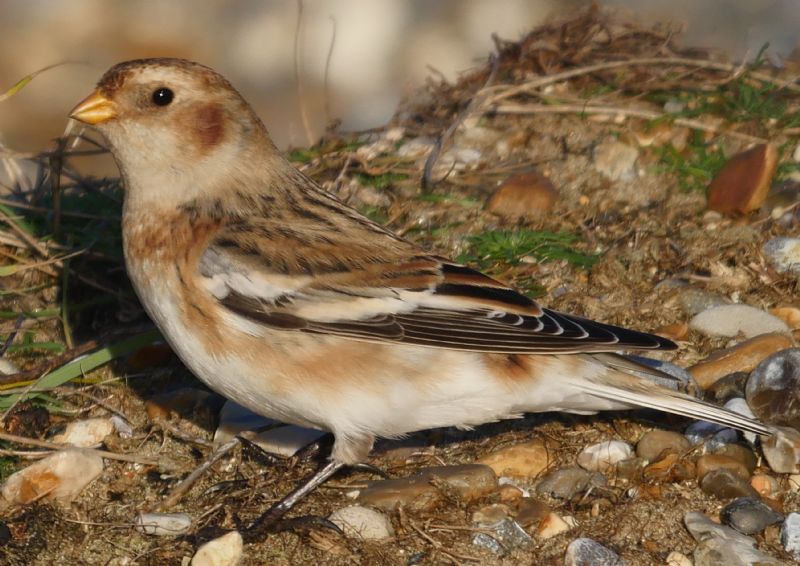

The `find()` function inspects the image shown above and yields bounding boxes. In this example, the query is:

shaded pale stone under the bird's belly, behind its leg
[214,401,327,458]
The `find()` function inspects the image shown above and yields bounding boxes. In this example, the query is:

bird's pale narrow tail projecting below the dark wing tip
[580,355,775,436]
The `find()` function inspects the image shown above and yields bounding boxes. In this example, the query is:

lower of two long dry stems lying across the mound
[490,104,767,143]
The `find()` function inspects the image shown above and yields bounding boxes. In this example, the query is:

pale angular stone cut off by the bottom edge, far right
[683,511,781,566]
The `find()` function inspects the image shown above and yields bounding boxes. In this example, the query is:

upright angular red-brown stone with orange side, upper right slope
[708,143,778,214]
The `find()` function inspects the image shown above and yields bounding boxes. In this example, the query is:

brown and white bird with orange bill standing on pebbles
[69,58,772,524]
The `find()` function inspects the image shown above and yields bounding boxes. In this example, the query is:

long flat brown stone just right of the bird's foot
[357,464,497,511]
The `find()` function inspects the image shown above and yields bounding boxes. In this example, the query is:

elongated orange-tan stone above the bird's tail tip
[689,333,794,389]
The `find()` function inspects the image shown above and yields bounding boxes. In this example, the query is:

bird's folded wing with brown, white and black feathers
[199,211,675,354]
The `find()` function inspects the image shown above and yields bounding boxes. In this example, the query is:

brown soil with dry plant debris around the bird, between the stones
[0,5,800,565]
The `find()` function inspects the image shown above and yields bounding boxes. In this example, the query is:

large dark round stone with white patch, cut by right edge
[745,348,800,429]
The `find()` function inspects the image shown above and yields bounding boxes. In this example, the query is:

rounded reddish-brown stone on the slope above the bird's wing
[486,171,558,221]
